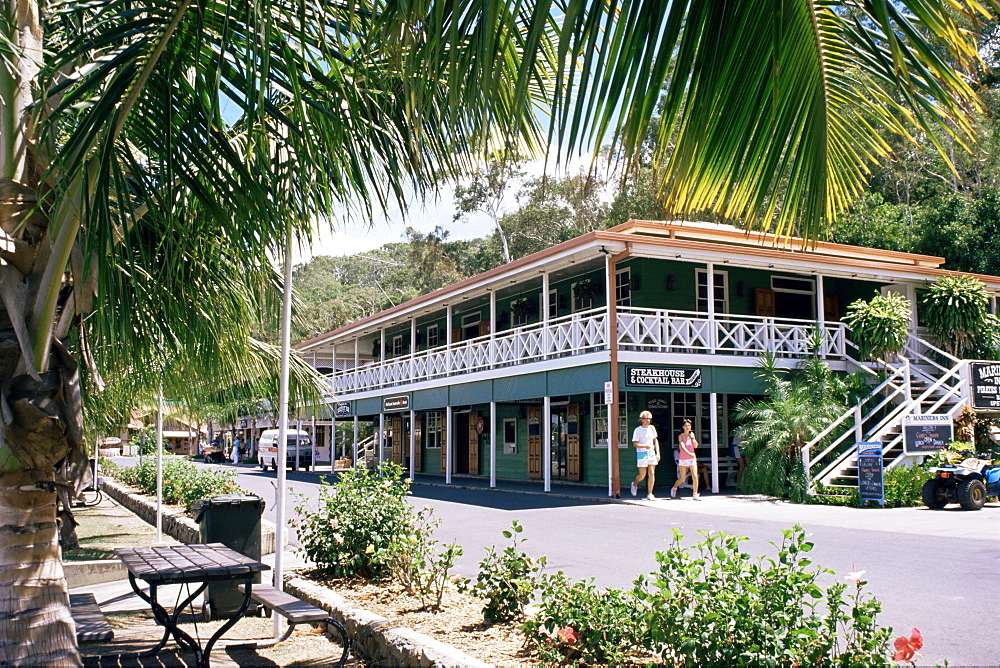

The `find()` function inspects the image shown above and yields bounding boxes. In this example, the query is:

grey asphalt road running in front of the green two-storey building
[207,468,1000,666]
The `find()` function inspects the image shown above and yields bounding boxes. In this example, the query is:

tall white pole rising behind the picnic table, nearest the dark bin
[274,224,292,638]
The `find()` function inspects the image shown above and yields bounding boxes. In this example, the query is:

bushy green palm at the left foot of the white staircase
[733,355,866,502]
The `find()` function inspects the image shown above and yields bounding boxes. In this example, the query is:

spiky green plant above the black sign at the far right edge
[920,276,1000,358]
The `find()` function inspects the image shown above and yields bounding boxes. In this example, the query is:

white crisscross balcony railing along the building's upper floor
[333,308,847,394]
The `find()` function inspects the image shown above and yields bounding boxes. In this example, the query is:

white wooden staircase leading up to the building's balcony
[802,334,969,493]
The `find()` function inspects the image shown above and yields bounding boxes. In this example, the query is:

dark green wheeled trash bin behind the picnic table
[193,494,264,620]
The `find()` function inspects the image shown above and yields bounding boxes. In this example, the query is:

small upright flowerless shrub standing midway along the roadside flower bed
[461,520,545,623]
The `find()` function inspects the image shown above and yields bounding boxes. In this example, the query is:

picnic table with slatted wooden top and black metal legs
[115,543,270,667]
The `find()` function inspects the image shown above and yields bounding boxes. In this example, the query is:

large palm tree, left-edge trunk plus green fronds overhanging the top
[0,0,977,664]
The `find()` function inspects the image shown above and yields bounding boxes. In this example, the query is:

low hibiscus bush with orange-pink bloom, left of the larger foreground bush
[521,571,645,666]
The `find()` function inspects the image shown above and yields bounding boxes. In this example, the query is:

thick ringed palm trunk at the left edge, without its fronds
[0,0,85,666]
